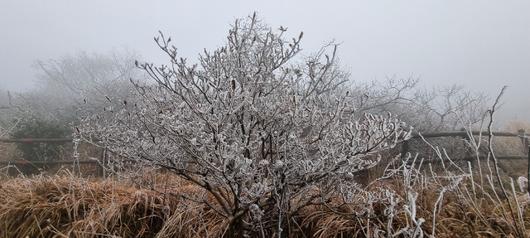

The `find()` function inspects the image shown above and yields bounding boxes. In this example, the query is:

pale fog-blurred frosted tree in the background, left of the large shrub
[12,51,141,124]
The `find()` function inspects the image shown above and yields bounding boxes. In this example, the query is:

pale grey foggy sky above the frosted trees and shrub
[0,0,530,122]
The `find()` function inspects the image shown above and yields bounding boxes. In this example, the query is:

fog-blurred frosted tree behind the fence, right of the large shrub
[350,78,488,132]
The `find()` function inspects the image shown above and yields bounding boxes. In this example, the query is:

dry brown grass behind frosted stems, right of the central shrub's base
[296,180,530,238]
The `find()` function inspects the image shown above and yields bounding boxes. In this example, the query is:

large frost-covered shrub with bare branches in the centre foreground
[79,15,409,237]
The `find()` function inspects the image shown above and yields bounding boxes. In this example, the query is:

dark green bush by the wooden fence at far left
[11,118,71,161]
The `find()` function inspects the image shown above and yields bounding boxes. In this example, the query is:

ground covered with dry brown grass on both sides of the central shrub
[0,167,530,237]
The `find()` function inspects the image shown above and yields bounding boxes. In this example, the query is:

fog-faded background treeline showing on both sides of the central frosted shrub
[0,50,502,139]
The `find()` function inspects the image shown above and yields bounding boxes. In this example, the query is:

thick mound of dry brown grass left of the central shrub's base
[0,170,227,237]
